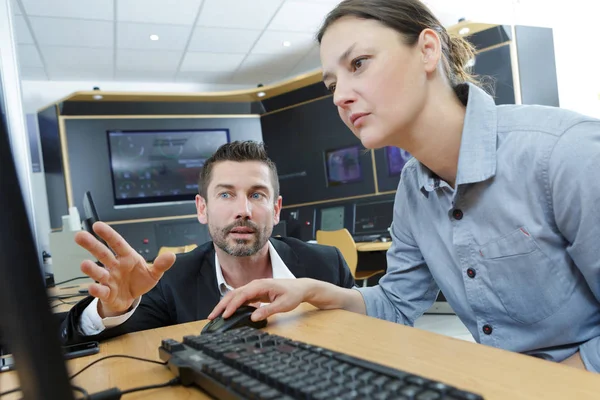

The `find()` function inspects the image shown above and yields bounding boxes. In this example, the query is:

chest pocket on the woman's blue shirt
[480,227,569,324]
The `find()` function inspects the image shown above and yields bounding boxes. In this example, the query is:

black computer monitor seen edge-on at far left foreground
[0,77,74,400]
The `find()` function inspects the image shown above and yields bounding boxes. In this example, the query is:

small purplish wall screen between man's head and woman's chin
[325,146,362,186]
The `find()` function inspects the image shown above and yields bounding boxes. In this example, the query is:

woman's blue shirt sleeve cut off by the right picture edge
[548,121,600,371]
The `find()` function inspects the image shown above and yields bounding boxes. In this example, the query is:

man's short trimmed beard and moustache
[208,220,270,257]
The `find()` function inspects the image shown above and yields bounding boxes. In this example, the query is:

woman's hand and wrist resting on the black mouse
[208,278,366,321]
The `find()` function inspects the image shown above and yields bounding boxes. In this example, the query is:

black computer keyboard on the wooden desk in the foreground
[159,327,483,400]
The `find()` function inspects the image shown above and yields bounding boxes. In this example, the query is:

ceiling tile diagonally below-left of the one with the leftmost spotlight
[42,46,114,70]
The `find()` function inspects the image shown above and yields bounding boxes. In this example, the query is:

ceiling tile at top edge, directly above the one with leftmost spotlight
[117,0,202,25]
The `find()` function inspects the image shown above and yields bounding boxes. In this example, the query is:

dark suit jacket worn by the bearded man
[61,237,354,344]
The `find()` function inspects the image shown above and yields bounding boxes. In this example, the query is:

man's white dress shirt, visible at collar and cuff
[79,241,296,336]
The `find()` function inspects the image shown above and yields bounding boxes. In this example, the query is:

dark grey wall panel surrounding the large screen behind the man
[57,116,262,228]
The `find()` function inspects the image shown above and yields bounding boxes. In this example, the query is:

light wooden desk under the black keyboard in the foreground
[0,305,600,400]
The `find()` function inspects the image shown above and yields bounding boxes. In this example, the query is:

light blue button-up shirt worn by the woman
[357,85,600,372]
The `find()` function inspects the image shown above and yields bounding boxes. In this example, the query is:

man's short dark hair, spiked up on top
[198,140,279,202]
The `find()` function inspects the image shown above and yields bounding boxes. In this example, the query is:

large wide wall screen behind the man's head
[108,129,229,206]
